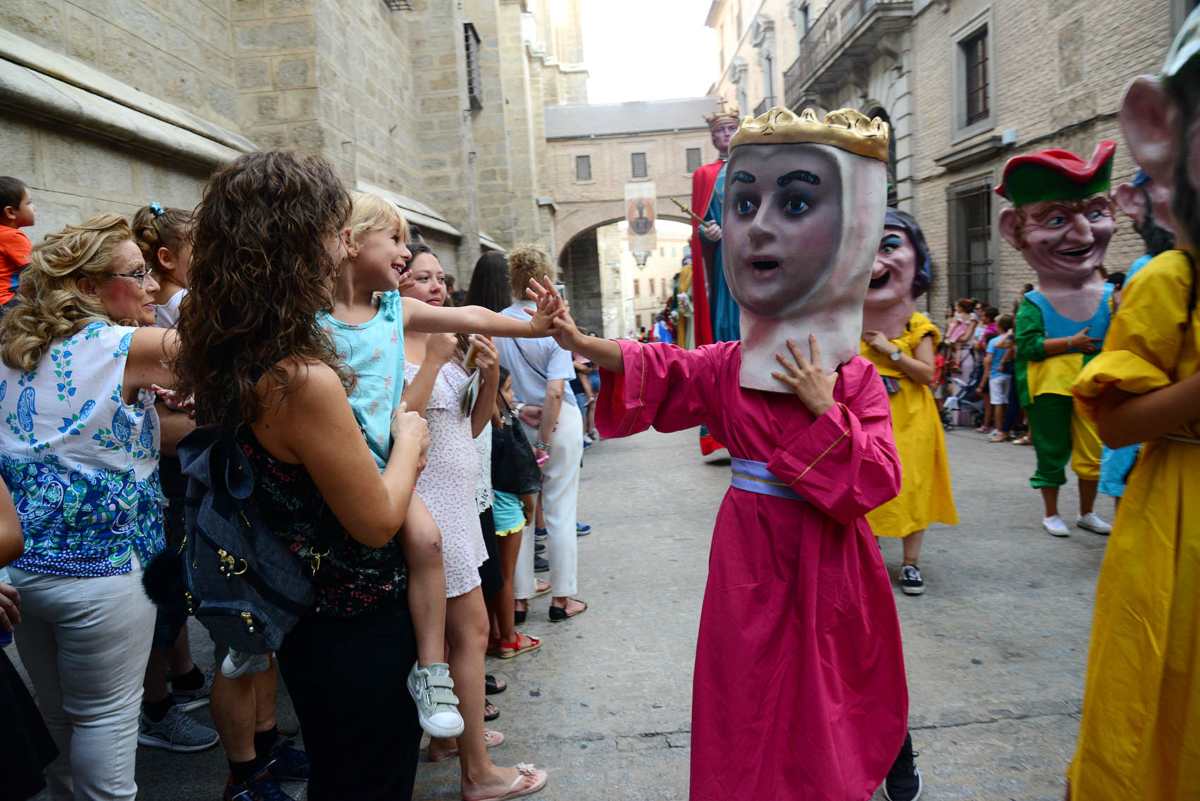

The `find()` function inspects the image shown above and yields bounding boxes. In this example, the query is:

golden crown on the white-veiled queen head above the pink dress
[730,108,889,163]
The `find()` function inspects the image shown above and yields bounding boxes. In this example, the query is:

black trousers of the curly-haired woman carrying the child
[278,609,421,801]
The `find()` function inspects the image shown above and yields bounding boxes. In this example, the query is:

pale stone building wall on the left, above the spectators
[0,0,587,278]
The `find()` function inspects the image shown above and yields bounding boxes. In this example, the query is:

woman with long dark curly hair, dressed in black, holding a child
[176,151,428,801]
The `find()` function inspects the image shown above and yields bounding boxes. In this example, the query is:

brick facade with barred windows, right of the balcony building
[911,0,1194,317]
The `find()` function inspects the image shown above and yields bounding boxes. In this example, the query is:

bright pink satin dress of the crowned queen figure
[596,342,908,801]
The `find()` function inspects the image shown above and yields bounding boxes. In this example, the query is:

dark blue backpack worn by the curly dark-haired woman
[178,426,314,654]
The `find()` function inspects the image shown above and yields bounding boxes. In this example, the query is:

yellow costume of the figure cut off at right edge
[1069,251,1200,801]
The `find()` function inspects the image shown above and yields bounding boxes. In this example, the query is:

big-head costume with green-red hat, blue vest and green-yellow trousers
[996,140,1116,489]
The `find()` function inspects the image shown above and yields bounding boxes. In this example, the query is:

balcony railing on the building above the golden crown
[784,0,912,107]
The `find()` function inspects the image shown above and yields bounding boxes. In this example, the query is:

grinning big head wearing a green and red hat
[996,139,1117,289]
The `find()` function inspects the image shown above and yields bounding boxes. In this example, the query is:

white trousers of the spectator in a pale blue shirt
[512,399,583,600]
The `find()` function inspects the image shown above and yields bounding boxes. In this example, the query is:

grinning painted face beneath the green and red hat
[1013,195,1116,283]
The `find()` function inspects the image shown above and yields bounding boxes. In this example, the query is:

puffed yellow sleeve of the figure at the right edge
[1073,251,1192,404]
